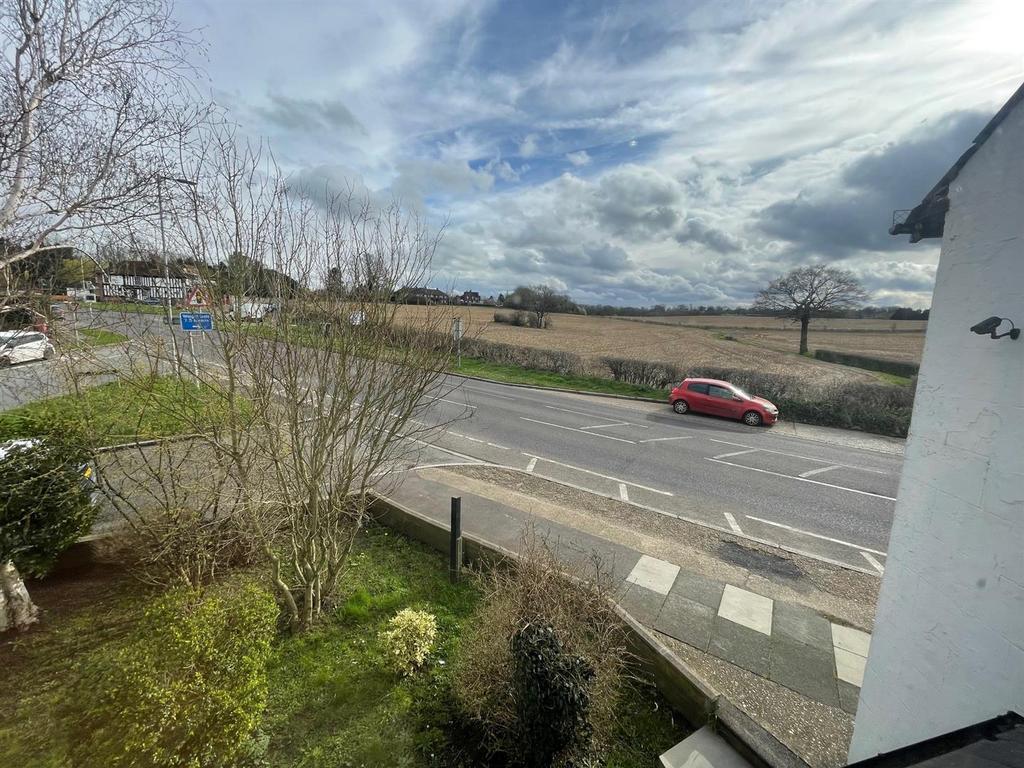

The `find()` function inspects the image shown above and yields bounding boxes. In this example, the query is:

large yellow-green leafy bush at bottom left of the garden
[62,584,278,768]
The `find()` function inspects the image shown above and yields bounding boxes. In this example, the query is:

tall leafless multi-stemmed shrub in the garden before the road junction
[79,133,460,631]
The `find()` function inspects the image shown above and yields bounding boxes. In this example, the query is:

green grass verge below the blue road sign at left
[0,378,245,444]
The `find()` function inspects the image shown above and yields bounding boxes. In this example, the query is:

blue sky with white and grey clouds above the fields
[176,0,1024,307]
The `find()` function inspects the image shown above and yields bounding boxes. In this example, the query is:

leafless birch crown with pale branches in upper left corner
[0,0,208,268]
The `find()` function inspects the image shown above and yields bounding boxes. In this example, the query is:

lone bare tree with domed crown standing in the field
[754,264,868,354]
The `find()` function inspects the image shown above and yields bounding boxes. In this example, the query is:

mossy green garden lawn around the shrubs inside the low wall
[0,528,686,768]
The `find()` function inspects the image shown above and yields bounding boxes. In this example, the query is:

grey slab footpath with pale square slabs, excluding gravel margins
[388,471,870,715]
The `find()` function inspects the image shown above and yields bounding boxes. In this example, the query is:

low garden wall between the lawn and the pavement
[373,497,807,768]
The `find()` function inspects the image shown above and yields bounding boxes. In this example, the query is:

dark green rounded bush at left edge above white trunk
[0,425,96,578]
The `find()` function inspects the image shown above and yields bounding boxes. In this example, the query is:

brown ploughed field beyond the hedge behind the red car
[389,305,925,386]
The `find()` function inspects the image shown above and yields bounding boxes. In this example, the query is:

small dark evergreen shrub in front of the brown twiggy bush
[512,621,594,768]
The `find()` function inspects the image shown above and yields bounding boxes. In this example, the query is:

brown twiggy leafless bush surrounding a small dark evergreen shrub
[454,534,628,757]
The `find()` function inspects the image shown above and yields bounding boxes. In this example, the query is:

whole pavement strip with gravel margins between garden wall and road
[388,465,879,768]
